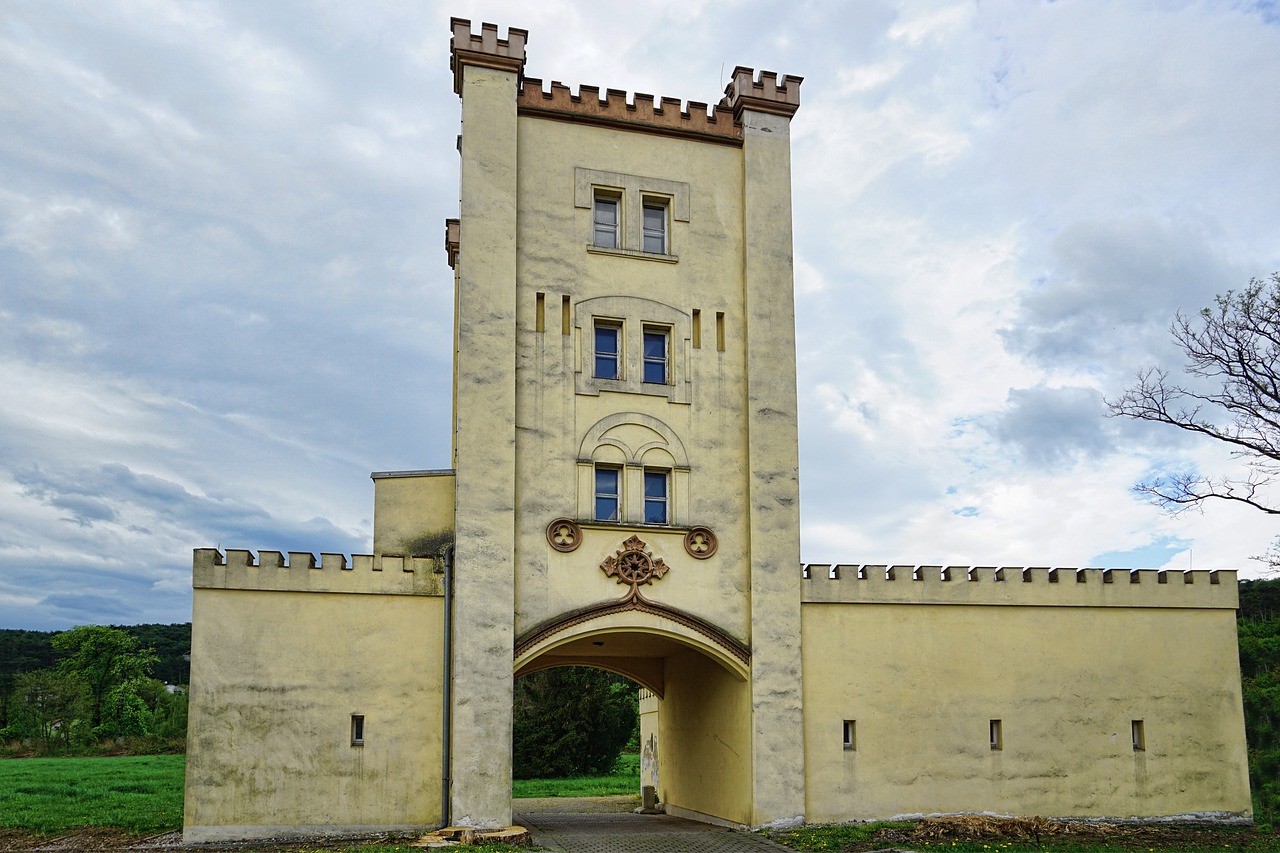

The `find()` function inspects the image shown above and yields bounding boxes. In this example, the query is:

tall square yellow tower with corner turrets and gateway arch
[447,19,804,826]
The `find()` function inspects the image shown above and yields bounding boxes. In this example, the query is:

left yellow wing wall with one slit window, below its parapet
[184,584,444,843]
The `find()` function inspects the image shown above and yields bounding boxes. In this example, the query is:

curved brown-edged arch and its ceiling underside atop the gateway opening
[513,601,750,698]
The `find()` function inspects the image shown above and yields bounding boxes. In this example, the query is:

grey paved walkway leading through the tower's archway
[512,797,794,853]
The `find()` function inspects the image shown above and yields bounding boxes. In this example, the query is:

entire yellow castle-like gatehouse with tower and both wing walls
[186,19,1249,841]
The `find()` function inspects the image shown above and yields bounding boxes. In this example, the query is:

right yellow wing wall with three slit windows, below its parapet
[803,594,1251,822]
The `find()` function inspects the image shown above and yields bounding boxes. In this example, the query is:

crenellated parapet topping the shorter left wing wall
[192,548,444,596]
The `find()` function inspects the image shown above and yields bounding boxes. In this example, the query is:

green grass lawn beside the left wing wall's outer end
[0,756,186,834]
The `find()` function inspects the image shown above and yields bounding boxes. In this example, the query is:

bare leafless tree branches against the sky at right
[1107,273,1280,567]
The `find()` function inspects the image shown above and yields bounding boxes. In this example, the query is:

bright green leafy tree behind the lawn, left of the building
[54,625,156,736]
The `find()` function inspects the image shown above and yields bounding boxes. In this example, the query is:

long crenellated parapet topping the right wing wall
[801,564,1239,610]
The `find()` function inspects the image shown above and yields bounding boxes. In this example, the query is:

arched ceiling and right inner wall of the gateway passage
[515,611,751,826]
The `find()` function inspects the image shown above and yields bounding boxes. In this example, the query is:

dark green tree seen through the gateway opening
[512,666,639,779]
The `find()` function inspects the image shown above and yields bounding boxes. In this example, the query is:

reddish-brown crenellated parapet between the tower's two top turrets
[518,77,742,145]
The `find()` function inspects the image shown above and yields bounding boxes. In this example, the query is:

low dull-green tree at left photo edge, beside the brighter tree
[8,670,90,754]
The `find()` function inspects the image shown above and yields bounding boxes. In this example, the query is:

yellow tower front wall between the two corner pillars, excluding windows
[504,117,752,640]
